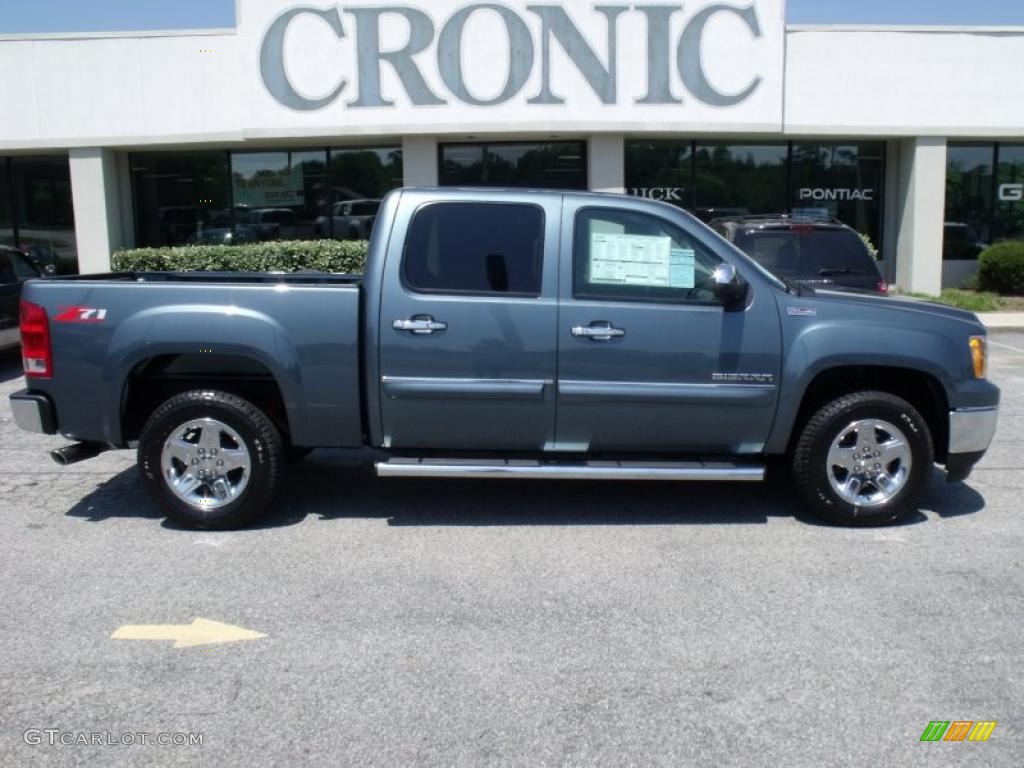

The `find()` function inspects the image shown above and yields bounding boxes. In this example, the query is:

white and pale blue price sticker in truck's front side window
[589,232,675,288]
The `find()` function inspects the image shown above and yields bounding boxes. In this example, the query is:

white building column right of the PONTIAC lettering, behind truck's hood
[896,137,946,295]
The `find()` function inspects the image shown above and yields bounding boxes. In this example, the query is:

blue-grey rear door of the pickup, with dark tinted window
[378,193,561,451]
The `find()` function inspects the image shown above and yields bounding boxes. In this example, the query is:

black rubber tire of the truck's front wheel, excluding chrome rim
[793,391,935,526]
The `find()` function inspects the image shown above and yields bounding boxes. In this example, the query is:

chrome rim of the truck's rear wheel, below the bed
[160,419,252,511]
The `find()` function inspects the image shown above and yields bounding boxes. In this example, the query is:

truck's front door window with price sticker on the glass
[572,208,722,304]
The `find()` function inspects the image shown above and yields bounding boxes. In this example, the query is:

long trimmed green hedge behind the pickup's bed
[112,240,368,273]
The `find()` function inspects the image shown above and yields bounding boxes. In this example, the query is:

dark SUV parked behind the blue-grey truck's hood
[711,214,889,296]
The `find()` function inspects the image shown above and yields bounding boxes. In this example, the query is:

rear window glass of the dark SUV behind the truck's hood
[736,228,878,278]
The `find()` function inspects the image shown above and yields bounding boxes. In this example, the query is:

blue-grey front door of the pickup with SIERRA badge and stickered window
[556,199,781,454]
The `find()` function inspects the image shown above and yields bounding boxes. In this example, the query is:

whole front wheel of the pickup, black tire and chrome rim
[793,392,934,525]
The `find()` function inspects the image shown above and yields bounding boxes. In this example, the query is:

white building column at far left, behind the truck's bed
[68,147,123,274]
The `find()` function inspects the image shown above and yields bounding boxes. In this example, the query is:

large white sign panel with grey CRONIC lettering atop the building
[241,0,782,131]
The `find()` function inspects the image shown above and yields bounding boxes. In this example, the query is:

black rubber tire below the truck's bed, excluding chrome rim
[138,390,284,529]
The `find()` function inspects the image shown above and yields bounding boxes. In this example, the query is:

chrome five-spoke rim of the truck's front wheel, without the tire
[825,419,911,507]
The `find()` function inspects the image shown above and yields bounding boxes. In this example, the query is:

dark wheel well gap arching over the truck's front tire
[790,366,949,463]
